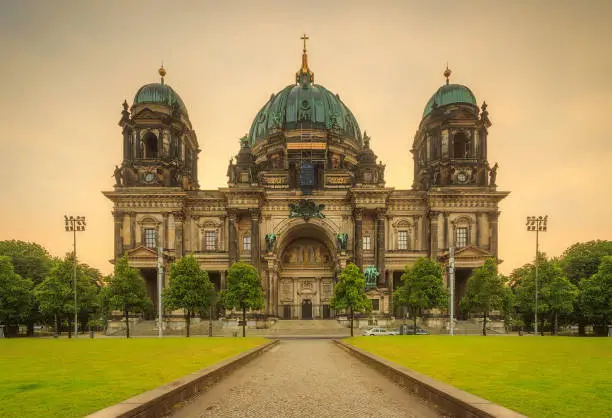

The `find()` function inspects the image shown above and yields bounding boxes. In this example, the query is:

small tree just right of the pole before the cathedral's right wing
[460,258,505,336]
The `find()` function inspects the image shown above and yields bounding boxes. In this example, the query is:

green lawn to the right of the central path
[347,335,612,417]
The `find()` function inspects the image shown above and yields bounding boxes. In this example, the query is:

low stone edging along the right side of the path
[334,340,526,418]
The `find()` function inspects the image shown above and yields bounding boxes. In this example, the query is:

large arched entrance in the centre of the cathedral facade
[277,223,336,319]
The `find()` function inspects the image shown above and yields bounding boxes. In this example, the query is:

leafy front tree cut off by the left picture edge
[0,256,33,333]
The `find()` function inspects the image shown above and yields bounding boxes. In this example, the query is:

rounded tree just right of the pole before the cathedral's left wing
[162,255,216,337]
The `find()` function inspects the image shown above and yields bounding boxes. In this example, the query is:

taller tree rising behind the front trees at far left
[0,240,52,335]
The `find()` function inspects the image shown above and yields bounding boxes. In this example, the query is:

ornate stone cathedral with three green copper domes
[104,37,509,319]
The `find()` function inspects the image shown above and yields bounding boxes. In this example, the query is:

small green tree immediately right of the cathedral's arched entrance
[330,263,372,337]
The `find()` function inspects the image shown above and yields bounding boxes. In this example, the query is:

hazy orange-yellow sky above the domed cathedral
[0,0,612,273]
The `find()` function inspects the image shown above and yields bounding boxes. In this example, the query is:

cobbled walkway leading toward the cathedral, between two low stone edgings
[173,340,439,418]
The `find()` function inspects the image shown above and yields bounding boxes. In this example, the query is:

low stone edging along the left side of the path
[87,340,279,418]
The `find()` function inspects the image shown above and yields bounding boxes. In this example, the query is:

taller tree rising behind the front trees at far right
[561,240,612,335]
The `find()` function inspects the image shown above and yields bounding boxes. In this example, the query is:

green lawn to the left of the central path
[0,338,266,417]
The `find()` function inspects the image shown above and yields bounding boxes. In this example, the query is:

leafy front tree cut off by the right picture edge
[580,256,612,335]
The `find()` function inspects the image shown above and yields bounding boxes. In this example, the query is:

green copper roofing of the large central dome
[249,83,361,144]
